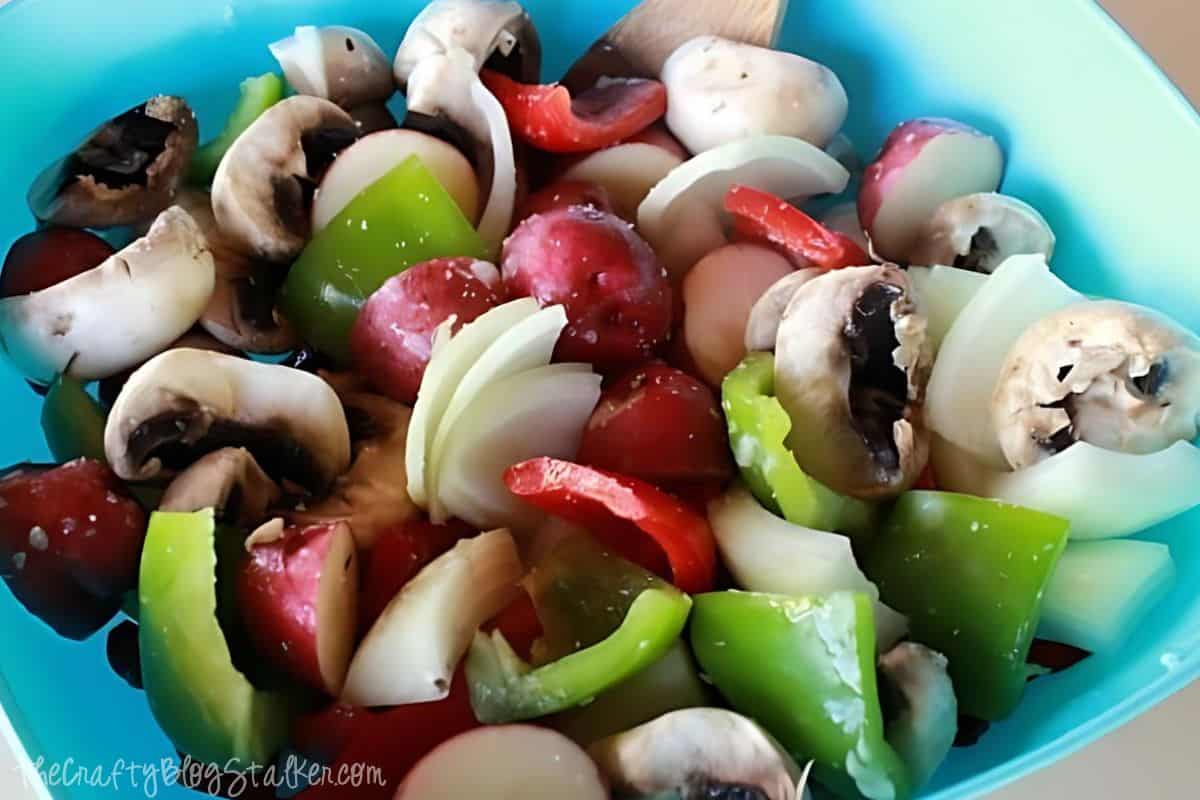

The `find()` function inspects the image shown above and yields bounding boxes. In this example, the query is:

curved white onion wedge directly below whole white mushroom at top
[637,136,850,277]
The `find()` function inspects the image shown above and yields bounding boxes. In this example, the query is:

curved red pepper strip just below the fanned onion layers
[504,457,716,594]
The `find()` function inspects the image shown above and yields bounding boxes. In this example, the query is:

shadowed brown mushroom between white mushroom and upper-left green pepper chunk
[179,190,300,354]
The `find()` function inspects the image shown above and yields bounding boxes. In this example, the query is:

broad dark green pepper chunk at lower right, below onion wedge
[863,492,1069,721]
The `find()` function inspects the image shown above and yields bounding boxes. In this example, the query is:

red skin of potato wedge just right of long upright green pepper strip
[236,523,358,694]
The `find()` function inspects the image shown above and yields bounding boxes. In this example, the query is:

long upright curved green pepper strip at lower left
[138,509,292,770]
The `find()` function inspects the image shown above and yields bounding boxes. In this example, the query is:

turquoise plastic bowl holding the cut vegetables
[0,0,1200,800]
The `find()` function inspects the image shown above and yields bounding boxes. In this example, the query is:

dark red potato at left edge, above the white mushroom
[0,228,116,297]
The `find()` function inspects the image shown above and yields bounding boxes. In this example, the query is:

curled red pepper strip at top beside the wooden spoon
[480,70,667,152]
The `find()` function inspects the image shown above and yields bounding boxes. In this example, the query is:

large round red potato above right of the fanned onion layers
[500,205,672,372]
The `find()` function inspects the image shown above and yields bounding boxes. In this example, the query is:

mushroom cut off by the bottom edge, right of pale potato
[588,709,805,800]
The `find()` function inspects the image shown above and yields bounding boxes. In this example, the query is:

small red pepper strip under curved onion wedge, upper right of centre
[725,186,872,270]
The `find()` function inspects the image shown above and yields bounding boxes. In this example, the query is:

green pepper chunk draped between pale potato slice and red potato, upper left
[281,156,487,365]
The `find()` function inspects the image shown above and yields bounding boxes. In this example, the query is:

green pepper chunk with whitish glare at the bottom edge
[691,591,910,800]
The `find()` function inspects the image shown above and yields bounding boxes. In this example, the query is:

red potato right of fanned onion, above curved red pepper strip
[577,362,733,485]
